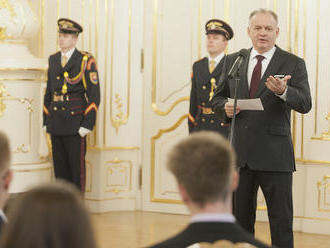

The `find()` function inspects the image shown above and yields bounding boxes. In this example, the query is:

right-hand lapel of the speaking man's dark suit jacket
[255,47,285,97]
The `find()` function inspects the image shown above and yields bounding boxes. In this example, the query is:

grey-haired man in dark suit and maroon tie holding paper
[213,9,312,248]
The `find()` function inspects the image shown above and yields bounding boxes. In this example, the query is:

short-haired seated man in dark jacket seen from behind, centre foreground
[151,131,268,248]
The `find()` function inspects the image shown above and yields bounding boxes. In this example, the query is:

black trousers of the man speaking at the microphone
[234,167,293,248]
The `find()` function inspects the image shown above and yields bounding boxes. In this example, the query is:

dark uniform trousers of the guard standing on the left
[51,134,86,192]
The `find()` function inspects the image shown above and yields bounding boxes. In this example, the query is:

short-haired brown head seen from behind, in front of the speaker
[168,131,238,213]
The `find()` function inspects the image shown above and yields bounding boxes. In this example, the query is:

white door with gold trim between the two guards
[142,0,205,213]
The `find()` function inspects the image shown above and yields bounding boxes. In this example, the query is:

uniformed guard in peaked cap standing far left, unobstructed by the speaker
[43,18,100,192]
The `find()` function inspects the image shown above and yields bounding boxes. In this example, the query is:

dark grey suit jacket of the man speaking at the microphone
[213,47,312,172]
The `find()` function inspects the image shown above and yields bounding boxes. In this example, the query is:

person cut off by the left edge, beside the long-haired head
[0,131,13,234]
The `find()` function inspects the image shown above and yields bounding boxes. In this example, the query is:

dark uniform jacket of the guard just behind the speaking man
[188,57,228,137]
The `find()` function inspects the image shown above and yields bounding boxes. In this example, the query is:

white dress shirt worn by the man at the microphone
[247,46,288,101]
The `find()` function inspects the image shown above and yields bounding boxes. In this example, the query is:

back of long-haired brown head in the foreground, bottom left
[0,181,96,248]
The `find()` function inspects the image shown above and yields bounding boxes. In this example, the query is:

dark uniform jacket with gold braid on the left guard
[43,49,100,135]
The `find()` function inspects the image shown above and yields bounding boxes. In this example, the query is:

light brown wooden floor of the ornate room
[92,211,330,248]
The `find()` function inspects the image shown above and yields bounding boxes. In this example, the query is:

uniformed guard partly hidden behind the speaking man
[188,19,234,137]
